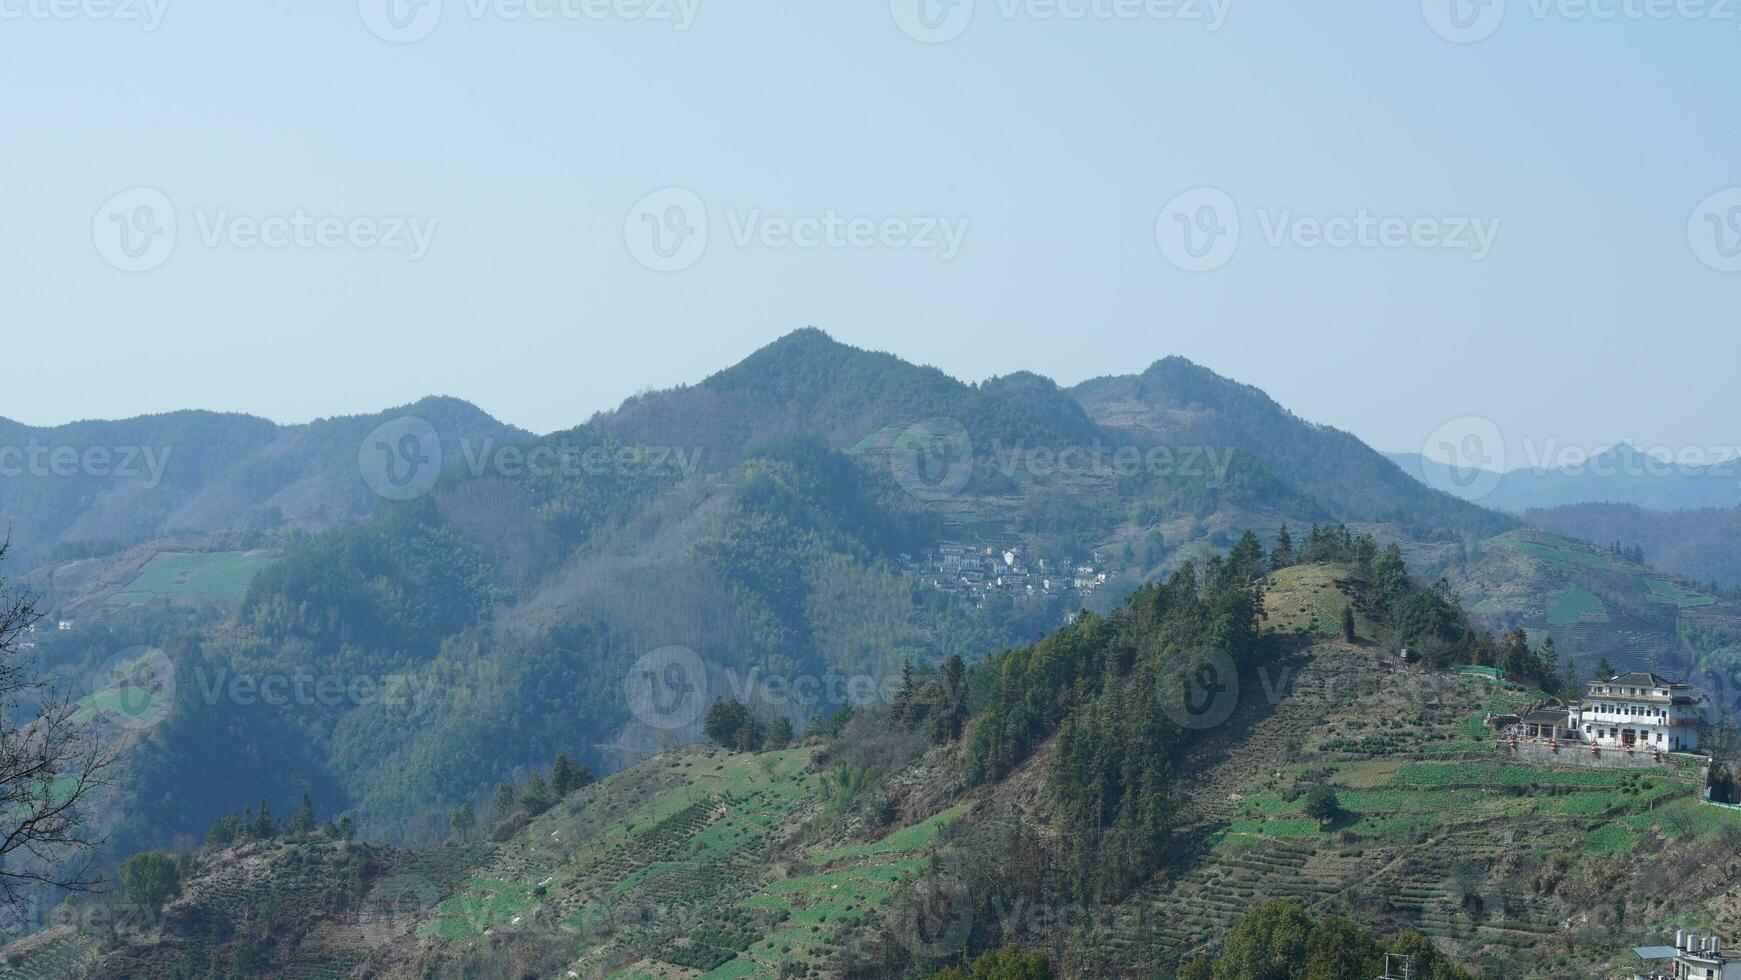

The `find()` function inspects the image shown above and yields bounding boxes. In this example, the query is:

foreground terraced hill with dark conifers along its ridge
[10,555,1741,980]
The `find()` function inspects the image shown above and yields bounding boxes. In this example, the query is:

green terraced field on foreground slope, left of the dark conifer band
[403,747,966,980]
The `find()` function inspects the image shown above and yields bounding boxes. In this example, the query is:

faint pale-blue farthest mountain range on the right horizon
[1388,442,1741,513]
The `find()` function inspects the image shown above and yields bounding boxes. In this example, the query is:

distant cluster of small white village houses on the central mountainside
[900,541,1109,606]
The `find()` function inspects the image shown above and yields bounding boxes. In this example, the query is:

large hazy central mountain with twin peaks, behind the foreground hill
[0,331,1566,905]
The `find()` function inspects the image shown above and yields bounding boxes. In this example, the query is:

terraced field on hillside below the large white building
[1106,626,1741,977]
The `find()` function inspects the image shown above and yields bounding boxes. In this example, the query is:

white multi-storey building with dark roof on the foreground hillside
[1567,672,1711,752]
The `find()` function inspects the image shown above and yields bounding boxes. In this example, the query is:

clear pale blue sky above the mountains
[0,0,1741,468]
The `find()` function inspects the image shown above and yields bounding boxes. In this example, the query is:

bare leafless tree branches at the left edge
[0,541,117,910]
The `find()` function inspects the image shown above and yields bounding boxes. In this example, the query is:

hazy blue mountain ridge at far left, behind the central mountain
[0,399,529,564]
